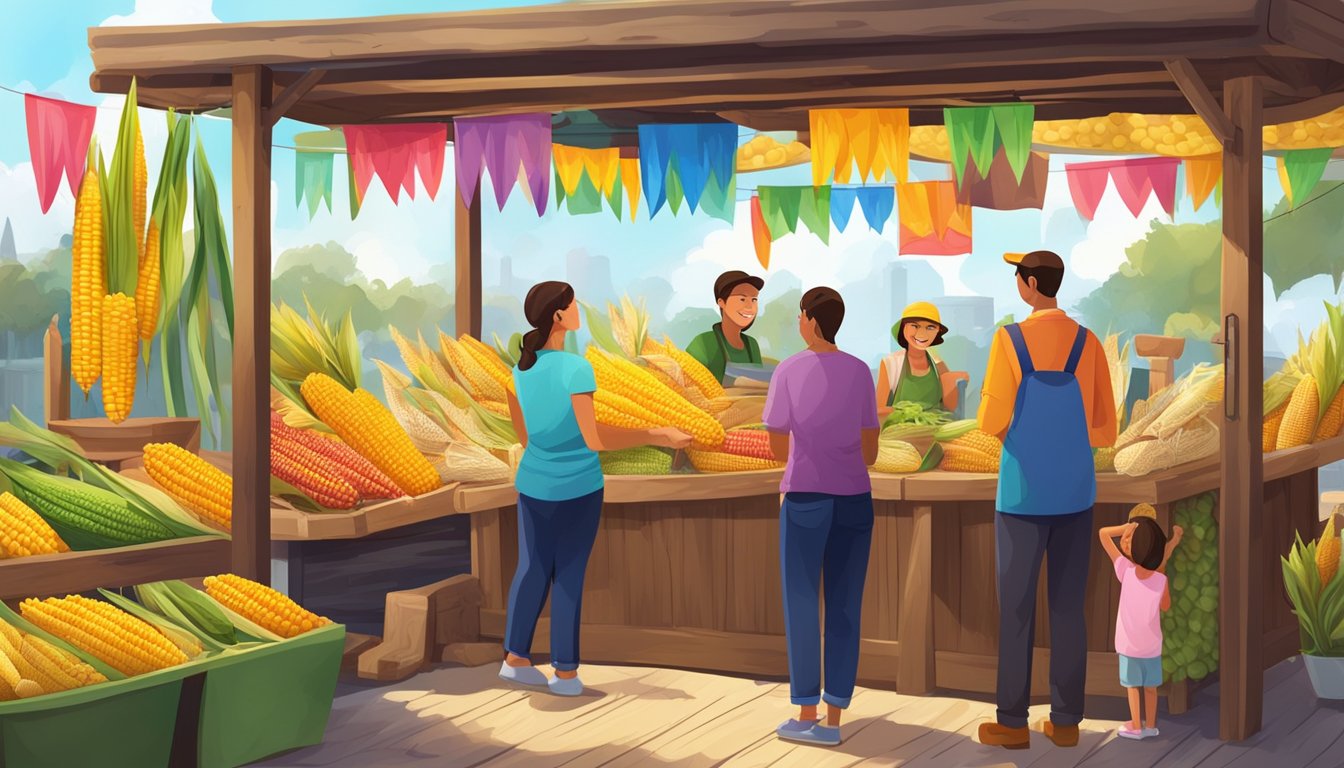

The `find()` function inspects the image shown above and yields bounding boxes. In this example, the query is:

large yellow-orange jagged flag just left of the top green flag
[808,109,910,187]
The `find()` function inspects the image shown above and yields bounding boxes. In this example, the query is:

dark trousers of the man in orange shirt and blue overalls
[995,510,1097,728]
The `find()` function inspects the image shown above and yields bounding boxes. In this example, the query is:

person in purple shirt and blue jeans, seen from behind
[765,288,879,746]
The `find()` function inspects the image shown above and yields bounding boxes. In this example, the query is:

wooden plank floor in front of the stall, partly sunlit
[265,659,1344,768]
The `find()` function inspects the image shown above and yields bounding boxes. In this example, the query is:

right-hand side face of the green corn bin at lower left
[196,624,345,768]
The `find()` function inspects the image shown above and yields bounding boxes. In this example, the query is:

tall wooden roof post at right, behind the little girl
[1219,78,1263,741]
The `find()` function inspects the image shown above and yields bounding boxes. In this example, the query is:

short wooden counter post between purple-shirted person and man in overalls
[896,504,937,695]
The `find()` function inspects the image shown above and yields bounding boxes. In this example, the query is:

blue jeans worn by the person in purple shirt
[780,494,872,709]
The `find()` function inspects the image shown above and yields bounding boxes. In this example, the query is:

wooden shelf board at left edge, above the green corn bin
[0,537,231,600]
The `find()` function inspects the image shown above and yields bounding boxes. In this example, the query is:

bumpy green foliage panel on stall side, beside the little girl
[1163,492,1218,682]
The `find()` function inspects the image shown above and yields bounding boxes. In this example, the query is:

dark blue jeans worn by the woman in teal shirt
[504,491,602,671]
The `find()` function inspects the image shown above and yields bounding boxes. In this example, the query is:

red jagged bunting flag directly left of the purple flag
[341,122,448,203]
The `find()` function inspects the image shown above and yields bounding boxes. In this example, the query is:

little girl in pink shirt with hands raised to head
[1099,504,1184,740]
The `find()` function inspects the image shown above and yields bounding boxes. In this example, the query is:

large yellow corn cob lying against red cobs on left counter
[300,373,442,496]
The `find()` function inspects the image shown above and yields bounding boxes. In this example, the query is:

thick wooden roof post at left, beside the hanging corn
[233,65,270,584]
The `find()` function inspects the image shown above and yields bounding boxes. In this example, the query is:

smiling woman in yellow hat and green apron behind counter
[878,301,970,418]
